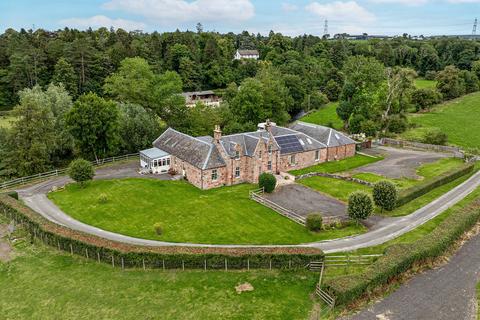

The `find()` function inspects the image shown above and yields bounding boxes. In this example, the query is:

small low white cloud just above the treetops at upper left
[60,15,146,31]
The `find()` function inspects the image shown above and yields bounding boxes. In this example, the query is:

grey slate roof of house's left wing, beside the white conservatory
[153,128,225,170]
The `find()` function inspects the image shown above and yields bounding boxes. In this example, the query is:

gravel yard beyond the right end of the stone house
[355,147,452,179]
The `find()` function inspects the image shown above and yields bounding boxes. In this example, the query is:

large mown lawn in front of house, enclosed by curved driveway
[49,179,364,244]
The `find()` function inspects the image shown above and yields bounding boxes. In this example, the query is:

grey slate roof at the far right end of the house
[290,121,356,147]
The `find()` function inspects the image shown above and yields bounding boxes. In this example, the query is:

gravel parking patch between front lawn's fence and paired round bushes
[264,184,347,217]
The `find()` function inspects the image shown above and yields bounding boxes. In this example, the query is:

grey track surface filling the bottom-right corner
[348,235,480,320]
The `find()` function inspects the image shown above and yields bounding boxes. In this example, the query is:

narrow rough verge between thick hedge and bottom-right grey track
[332,222,480,319]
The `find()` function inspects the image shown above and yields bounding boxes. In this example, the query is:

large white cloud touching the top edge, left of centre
[103,0,255,23]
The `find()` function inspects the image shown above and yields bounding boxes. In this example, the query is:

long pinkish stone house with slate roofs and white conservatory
[140,121,355,189]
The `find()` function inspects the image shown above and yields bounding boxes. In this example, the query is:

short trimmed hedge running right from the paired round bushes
[397,163,475,207]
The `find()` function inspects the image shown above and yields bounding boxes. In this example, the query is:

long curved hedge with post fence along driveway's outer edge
[0,195,324,269]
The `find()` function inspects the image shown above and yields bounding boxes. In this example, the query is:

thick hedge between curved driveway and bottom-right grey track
[323,198,480,305]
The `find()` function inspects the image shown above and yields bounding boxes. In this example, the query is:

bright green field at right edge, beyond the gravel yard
[402,92,480,148]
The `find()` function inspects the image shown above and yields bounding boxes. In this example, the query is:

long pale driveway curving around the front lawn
[18,167,480,253]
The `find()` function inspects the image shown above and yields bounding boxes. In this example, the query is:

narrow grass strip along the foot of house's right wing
[290,154,383,176]
